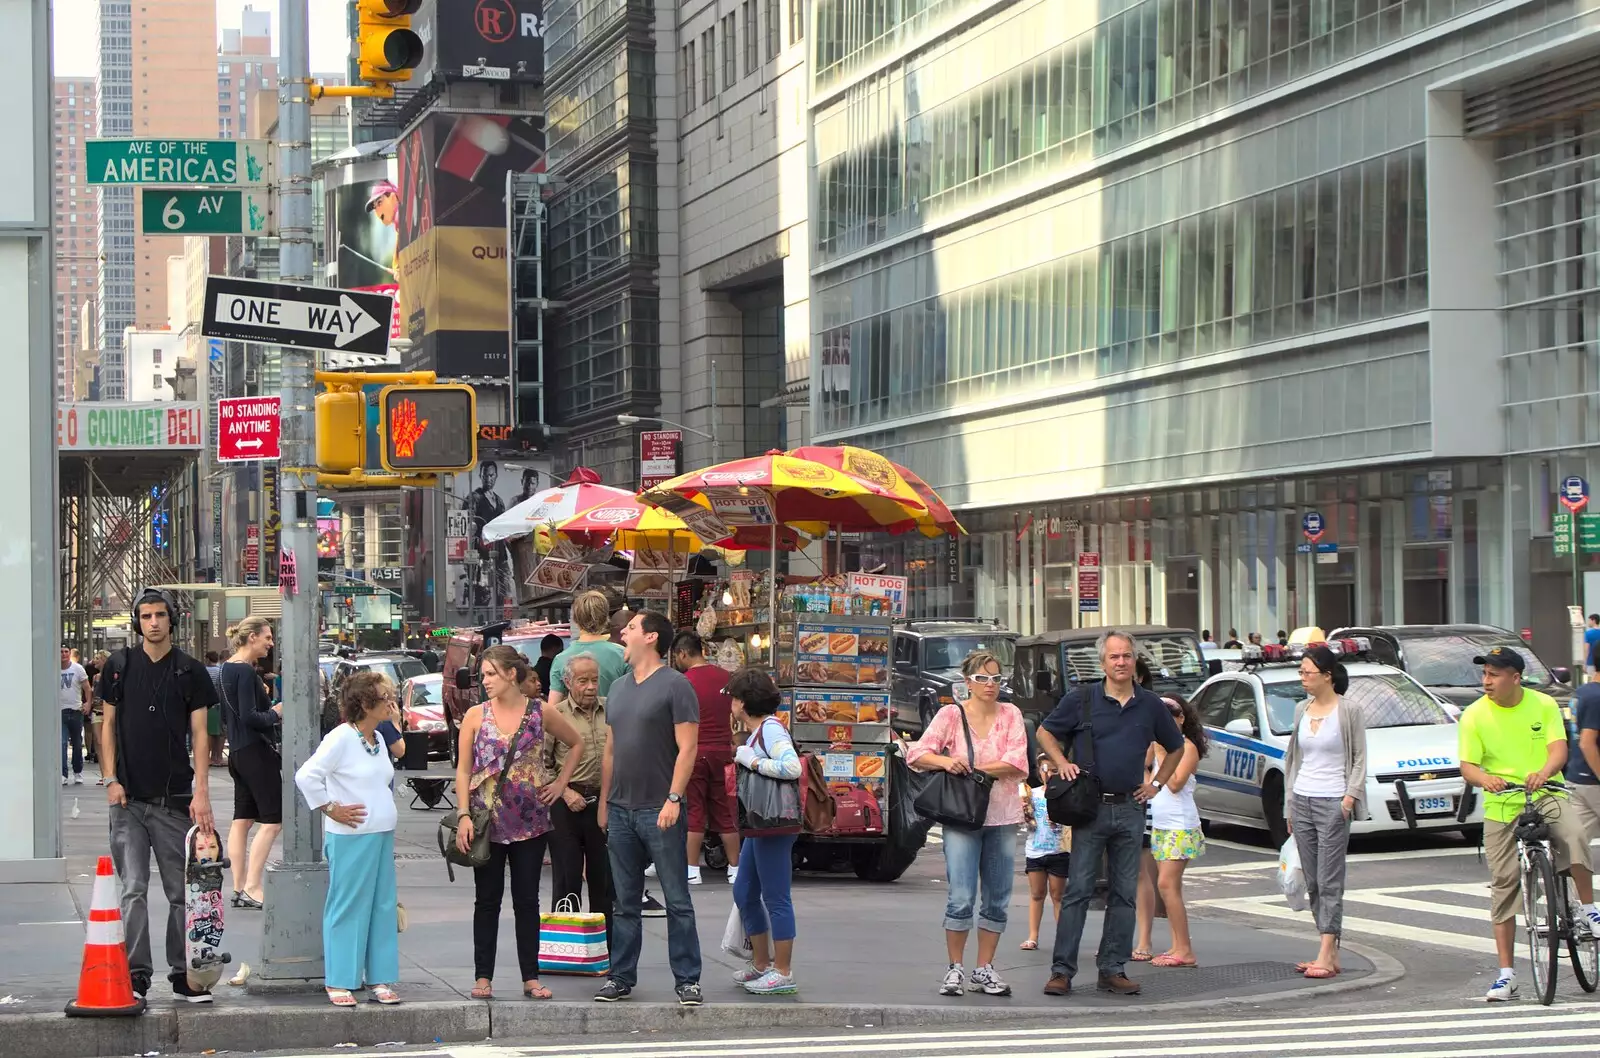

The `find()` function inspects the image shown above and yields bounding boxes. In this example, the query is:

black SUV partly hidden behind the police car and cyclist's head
[1328,624,1573,709]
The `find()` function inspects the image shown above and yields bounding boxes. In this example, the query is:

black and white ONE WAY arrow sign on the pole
[200,275,394,357]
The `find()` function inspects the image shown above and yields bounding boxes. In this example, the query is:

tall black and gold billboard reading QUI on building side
[395,112,544,379]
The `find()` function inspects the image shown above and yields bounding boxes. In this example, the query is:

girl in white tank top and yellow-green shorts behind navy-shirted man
[1139,695,1210,967]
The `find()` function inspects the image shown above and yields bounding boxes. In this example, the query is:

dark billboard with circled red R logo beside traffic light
[411,0,544,85]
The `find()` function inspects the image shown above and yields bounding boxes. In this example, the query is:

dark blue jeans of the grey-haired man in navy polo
[1056,800,1144,981]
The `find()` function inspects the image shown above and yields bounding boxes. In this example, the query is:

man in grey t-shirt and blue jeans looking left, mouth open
[595,611,702,1007]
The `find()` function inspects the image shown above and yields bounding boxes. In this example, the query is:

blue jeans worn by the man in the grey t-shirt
[606,805,701,988]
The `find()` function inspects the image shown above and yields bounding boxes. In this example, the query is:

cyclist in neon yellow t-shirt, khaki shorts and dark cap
[1461,647,1600,1002]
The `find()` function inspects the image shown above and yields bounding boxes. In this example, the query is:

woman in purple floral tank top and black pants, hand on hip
[456,643,584,999]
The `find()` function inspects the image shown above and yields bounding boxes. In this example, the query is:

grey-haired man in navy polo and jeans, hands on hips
[1038,629,1184,996]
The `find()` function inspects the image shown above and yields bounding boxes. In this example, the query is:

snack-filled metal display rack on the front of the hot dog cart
[776,613,893,840]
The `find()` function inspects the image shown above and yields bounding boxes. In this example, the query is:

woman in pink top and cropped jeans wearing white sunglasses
[906,650,1027,996]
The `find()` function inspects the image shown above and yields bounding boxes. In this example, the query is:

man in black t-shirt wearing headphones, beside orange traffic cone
[96,587,218,1004]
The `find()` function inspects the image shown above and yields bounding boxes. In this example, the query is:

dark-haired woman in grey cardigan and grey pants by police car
[1283,643,1366,978]
